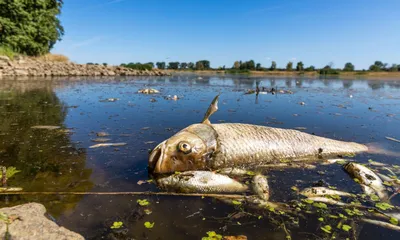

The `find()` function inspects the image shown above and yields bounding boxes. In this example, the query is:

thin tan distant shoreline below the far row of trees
[164,69,400,80]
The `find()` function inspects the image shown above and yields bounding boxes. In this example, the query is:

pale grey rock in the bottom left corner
[0,203,84,240]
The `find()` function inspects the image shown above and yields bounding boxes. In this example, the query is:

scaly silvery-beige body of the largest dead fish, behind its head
[212,123,368,168]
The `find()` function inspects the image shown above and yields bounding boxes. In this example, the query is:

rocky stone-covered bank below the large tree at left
[0,56,170,79]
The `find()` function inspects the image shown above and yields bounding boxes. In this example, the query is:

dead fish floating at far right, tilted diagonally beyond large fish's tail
[344,163,388,200]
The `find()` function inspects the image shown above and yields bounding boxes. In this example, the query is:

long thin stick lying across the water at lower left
[0,192,244,199]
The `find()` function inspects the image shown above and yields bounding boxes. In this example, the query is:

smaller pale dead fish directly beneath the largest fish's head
[157,171,248,193]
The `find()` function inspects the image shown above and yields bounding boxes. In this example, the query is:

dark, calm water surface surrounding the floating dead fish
[0,75,400,239]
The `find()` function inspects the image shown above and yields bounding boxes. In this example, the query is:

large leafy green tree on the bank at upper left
[0,0,64,56]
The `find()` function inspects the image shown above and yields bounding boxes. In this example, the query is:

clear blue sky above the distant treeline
[52,0,400,69]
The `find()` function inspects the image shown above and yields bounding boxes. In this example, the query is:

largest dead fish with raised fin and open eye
[149,96,368,173]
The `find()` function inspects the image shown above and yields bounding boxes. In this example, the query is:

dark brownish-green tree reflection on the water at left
[0,89,93,216]
